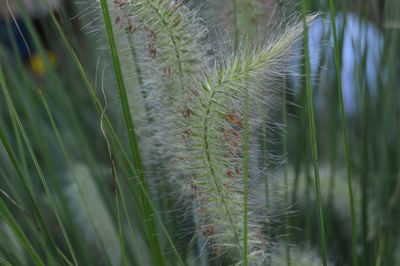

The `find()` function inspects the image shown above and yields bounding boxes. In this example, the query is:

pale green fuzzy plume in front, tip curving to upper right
[182,17,316,265]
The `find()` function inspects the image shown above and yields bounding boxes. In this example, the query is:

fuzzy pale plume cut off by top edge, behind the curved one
[95,0,210,172]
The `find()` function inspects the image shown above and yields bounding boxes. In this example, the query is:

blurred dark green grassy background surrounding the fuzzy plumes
[0,0,400,265]
